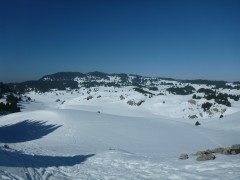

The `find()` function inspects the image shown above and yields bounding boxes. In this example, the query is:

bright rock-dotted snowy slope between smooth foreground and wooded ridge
[22,86,240,119]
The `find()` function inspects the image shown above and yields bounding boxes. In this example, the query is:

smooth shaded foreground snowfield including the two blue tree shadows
[0,93,240,180]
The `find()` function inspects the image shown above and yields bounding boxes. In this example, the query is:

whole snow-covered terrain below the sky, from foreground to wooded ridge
[0,72,240,180]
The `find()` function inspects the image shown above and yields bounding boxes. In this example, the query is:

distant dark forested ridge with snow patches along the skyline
[3,71,240,94]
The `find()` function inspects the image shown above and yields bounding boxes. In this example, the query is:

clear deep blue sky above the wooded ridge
[0,0,240,82]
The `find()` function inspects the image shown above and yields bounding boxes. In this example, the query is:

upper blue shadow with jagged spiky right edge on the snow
[0,120,61,143]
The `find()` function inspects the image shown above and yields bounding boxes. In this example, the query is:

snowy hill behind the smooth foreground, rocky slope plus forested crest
[9,72,240,119]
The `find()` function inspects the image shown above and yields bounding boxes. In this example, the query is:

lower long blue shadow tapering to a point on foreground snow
[0,148,94,168]
